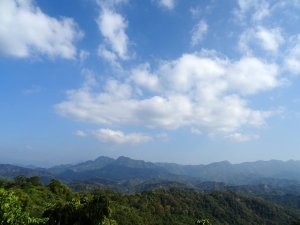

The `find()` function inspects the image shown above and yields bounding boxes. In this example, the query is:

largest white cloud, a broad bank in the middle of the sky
[55,53,281,134]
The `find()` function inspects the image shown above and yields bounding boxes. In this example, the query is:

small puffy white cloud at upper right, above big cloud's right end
[239,26,284,55]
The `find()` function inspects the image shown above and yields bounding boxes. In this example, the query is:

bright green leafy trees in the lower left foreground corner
[0,176,109,225]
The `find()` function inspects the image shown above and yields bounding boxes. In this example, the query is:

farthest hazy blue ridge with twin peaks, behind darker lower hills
[0,156,300,185]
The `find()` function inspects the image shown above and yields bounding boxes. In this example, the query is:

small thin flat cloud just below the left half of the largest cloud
[92,129,152,144]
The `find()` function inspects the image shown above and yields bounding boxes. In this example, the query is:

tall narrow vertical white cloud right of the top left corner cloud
[97,7,129,61]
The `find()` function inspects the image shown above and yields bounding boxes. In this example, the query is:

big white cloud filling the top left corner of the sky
[0,0,83,59]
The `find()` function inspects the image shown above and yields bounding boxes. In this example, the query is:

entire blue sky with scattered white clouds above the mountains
[0,0,300,167]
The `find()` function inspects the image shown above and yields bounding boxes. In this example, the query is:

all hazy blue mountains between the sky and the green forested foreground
[4,156,300,210]
